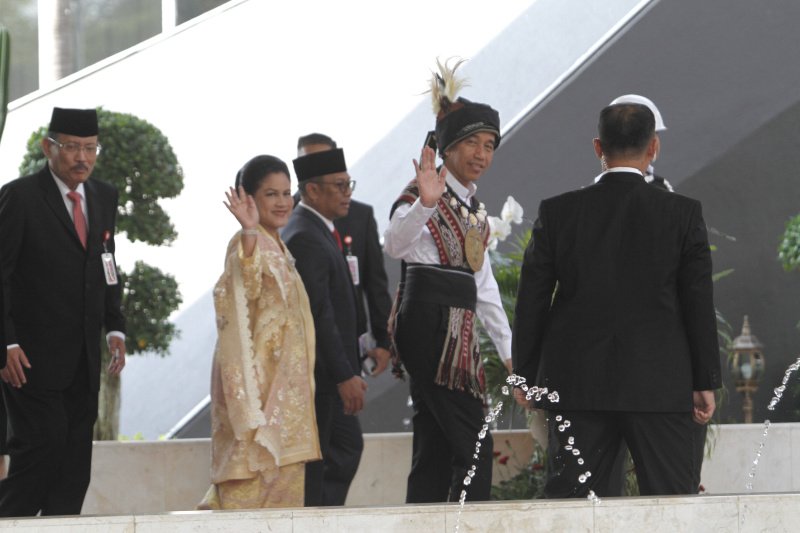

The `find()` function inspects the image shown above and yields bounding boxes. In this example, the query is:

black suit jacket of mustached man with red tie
[0,167,125,390]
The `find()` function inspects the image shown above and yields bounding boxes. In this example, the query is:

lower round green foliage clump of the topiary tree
[120,261,181,356]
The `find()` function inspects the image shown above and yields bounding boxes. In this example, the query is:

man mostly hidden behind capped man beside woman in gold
[297,133,392,376]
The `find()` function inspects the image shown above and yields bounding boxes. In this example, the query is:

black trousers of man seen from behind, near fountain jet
[545,411,698,498]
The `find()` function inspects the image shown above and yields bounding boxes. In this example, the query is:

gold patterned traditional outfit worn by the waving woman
[199,228,321,509]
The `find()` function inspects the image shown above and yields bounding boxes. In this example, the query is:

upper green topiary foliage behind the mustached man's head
[20,108,183,245]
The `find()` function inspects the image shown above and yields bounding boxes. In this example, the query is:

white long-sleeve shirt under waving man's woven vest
[383,172,511,361]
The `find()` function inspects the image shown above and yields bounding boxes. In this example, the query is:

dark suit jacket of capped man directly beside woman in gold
[281,206,360,393]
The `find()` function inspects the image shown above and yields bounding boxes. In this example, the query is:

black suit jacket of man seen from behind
[513,172,721,412]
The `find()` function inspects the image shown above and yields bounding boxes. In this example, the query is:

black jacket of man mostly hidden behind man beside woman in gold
[333,200,392,350]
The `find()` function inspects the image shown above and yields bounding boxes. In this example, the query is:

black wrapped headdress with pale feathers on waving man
[431,60,500,156]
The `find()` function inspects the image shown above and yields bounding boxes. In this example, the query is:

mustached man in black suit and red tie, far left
[0,108,125,516]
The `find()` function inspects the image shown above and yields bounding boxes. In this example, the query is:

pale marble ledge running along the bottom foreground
[0,493,800,533]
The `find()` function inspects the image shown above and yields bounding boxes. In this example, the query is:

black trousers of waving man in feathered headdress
[395,300,493,503]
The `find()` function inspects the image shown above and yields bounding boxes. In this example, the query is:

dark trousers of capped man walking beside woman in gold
[305,392,364,507]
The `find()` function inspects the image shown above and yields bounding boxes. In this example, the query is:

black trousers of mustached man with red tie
[0,359,97,517]
